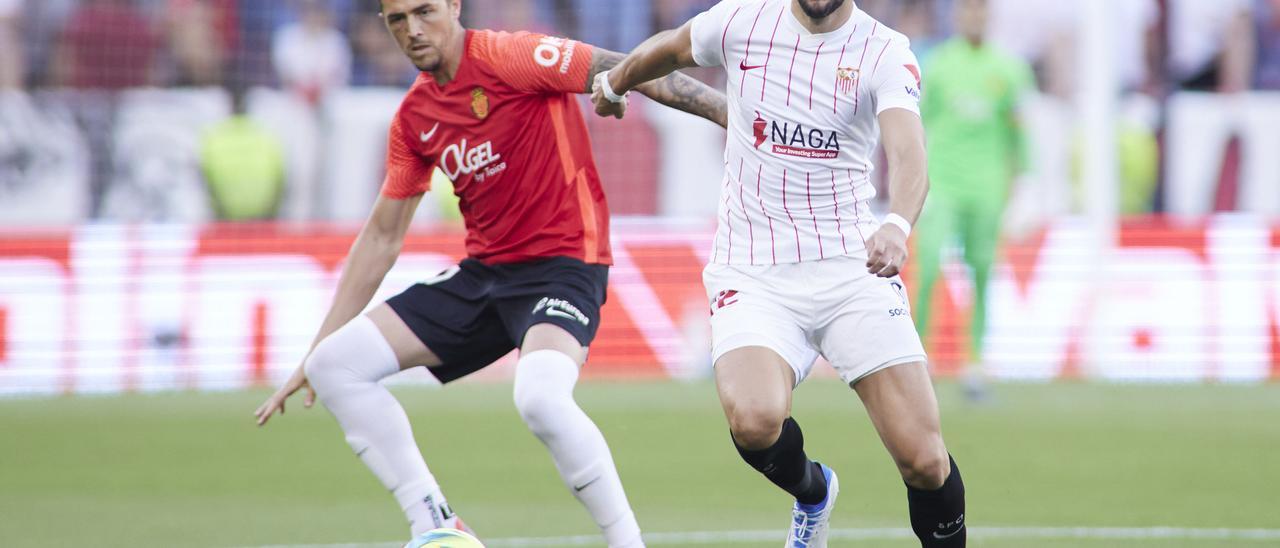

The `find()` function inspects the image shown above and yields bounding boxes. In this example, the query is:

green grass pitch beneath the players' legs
[0,380,1280,548]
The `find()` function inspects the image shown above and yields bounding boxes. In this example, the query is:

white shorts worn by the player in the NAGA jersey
[703,256,925,385]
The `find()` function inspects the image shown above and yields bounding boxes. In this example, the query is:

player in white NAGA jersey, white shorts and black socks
[593,0,965,548]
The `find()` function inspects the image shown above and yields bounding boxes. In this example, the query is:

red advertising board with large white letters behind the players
[0,216,1280,394]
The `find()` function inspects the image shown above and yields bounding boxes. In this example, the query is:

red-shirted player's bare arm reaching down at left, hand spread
[253,195,422,426]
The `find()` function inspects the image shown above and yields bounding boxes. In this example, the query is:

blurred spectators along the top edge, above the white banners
[0,0,1280,95]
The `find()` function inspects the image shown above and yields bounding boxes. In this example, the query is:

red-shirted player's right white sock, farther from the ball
[516,350,644,548]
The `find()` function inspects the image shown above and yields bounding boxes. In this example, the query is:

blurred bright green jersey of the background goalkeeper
[920,38,1034,200]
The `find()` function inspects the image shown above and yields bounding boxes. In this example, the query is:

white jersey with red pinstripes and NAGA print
[692,0,920,265]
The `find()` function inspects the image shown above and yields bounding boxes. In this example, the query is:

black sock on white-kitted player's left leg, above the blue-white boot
[733,417,827,504]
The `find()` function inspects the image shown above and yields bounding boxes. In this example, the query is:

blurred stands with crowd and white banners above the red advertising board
[0,0,1280,225]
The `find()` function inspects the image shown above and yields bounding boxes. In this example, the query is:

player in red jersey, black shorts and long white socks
[256,0,726,548]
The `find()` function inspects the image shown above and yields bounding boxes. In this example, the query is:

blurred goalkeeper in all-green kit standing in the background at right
[914,0,1034,398]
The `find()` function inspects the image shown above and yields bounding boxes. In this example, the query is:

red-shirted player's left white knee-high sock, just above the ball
[306,316,457,536]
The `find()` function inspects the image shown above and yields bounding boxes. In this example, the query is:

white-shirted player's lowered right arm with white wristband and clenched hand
[867,109,929,278]
